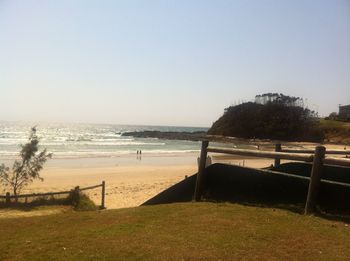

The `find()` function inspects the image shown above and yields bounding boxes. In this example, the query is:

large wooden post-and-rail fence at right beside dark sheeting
[194,139,350,214]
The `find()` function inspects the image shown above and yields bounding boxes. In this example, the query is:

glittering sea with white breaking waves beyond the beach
[0,122,207,159]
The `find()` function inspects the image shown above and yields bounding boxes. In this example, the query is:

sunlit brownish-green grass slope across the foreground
[0,203,350,260]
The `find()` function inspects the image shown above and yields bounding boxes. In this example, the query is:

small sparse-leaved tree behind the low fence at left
[0,127,52,196]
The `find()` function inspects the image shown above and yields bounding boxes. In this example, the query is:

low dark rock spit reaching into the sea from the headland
[122,131,206,141]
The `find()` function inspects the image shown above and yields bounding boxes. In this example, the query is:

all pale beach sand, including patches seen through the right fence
[2,143,343,209]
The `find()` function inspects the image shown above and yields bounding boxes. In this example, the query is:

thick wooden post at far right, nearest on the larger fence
[305,146,326,214]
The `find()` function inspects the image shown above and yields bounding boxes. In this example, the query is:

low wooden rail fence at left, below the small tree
[0,181,106,209]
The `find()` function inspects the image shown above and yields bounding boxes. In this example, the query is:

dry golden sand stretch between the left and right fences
[30,165,196,209]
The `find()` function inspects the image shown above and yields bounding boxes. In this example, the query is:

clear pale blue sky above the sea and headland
[0,0,350,126]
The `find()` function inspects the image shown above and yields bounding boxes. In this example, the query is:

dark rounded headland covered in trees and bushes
[208,93,323,141]
